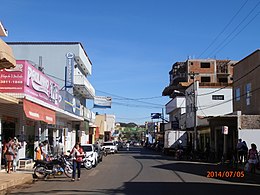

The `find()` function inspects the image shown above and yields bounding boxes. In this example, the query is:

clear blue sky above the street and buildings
[0,0,260,124]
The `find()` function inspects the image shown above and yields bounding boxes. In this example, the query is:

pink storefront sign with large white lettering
[0,60,60,107]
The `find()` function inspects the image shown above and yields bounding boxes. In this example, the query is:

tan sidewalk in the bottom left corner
[0,170,33,195]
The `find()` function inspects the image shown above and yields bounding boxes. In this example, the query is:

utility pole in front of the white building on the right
[189,72,199,151]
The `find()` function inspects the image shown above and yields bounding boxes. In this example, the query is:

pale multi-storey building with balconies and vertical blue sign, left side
[8,42,95,155]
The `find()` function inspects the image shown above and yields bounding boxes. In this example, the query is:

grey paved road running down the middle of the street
[5,148,260,195]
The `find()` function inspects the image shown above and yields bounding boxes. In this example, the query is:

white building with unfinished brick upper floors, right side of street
[162,59,235,154]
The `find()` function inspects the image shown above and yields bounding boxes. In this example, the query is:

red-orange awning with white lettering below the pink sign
[23,99,56,124]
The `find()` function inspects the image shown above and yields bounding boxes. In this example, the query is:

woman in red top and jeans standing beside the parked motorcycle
[70,143,84,181]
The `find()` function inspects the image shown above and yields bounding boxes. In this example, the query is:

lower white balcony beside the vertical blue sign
[74,75,95,99]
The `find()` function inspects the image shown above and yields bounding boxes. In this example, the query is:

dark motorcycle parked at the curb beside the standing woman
[34,155,73,179]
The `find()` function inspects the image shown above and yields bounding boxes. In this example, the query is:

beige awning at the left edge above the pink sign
[0,39,16,69]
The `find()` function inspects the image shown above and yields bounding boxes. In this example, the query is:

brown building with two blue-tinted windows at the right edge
[233,49,260,151]
